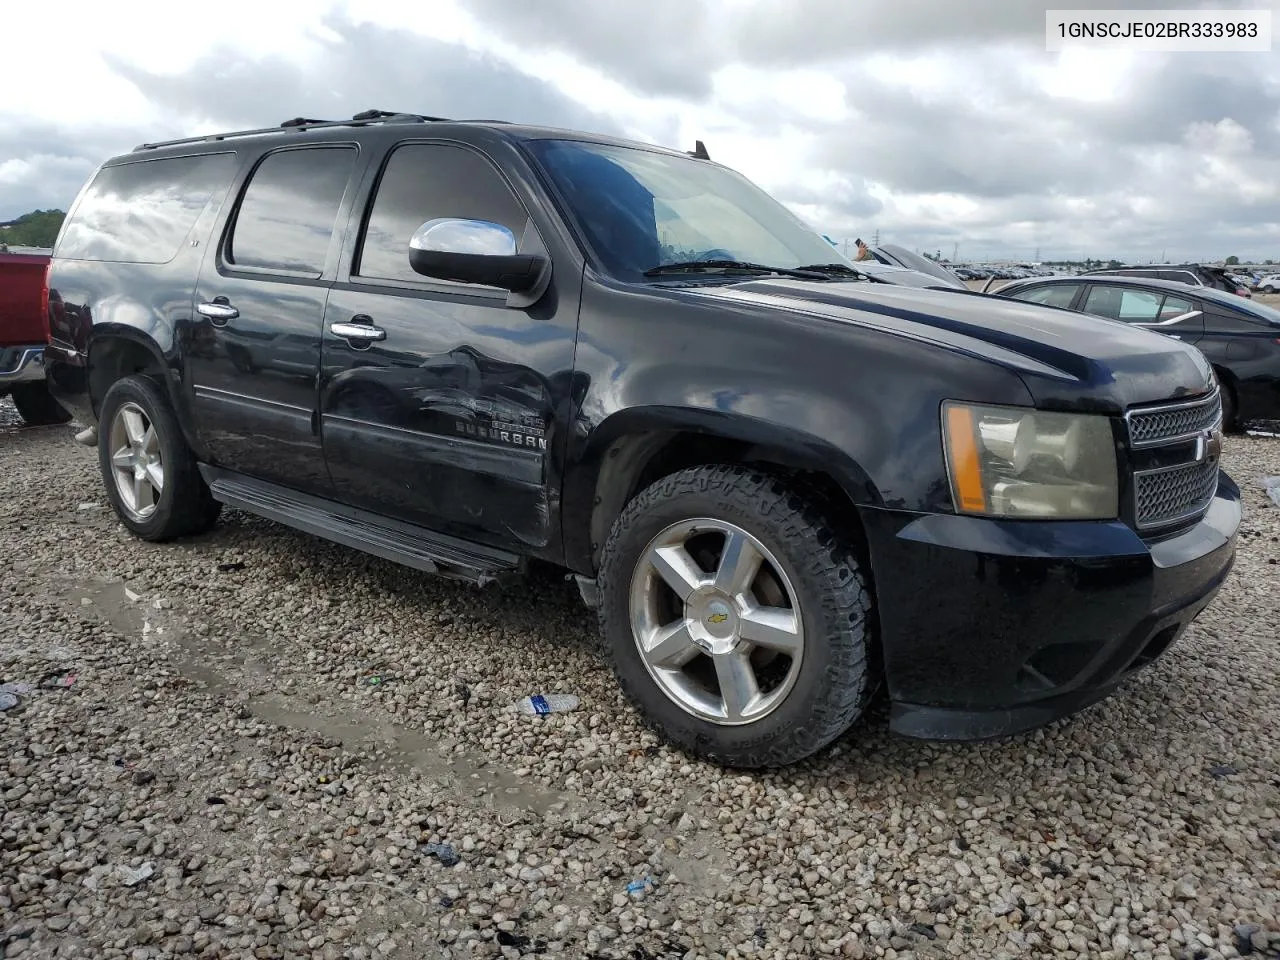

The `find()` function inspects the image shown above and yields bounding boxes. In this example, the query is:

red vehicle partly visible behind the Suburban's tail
[0,252,70,425]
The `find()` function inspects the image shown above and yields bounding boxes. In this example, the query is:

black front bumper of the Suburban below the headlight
[863,474,1240,740]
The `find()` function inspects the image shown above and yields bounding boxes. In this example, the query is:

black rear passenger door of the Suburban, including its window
[186,146,357,493]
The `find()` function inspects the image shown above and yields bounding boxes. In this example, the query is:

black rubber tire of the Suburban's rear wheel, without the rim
[97,375,223,543]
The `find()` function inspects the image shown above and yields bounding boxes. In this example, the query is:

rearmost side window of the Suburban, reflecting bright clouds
[56,154,236,264]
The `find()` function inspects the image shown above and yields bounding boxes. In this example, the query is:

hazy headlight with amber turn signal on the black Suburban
[942,401,1119,520]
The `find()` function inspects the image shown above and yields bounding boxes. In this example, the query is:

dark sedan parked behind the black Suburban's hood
[996,274,1280,430]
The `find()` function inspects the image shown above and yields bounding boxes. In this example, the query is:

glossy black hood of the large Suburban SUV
[682,279,1213,413]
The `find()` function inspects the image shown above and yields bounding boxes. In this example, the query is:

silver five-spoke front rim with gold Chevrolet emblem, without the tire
[630,520,804,726]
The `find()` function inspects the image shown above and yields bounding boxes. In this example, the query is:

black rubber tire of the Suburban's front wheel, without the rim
[598,465,877,768]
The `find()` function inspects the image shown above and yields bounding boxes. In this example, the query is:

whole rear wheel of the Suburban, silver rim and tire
[97,376,221,540]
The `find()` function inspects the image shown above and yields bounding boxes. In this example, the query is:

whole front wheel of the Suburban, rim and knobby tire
[599,466,874,768]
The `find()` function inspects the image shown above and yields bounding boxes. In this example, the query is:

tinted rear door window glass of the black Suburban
[227,147,356,276]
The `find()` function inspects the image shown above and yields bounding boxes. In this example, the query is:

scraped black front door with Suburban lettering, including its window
[320,142,580,553]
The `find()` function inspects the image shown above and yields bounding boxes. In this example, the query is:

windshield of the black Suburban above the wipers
[519,140,850,280]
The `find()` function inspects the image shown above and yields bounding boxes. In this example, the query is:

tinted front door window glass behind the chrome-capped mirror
[355,143,529,283]
